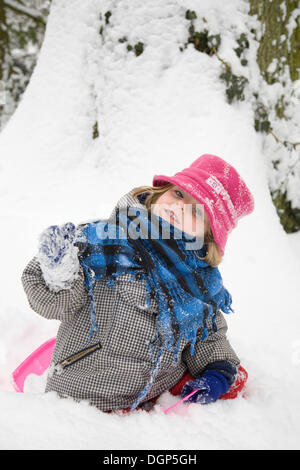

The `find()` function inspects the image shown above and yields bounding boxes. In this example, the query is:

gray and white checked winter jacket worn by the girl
[21,191,240,411]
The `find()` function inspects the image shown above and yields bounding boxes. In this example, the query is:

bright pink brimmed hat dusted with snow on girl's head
[152,154,254,256]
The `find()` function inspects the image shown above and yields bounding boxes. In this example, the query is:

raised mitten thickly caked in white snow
[37,222,80,292]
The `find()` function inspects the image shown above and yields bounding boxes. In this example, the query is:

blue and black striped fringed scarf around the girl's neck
[75,207,234,409]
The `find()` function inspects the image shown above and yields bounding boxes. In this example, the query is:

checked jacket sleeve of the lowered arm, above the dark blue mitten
[182,310,240,377]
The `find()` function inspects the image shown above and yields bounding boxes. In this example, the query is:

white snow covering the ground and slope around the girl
[0,0,300,449]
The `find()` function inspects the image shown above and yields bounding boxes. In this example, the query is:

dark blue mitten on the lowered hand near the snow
[181,370,230,405]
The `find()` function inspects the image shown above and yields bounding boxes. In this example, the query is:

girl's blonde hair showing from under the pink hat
[131,183,223,268]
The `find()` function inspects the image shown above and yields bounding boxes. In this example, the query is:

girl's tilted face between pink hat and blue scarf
[152,186,209,238]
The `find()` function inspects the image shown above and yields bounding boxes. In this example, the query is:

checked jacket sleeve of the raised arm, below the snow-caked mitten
[21,256,88,321]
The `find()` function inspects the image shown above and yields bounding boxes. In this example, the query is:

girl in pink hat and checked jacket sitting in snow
[22,154,254,411]
